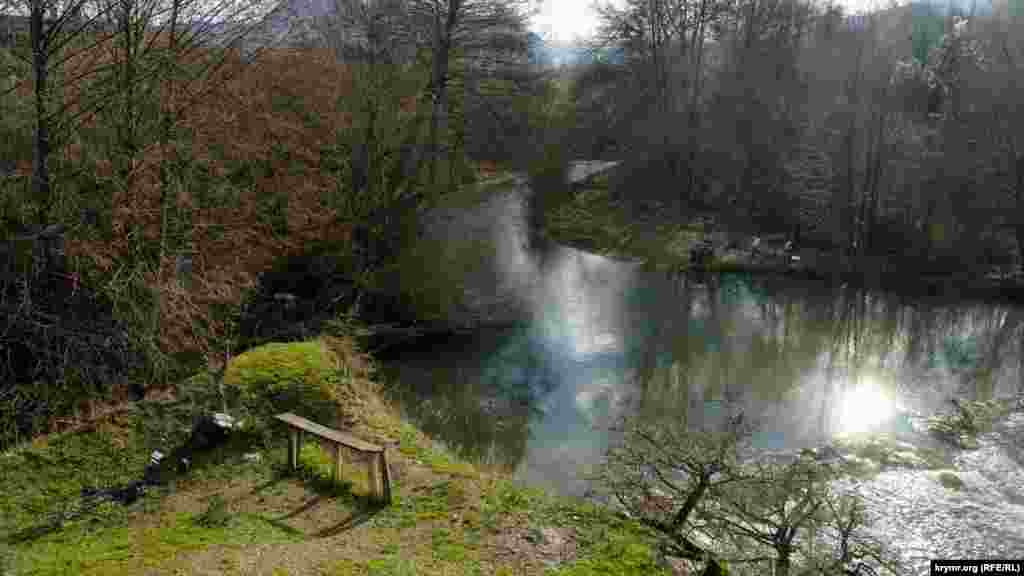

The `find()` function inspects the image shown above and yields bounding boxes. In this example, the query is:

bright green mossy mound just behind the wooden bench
[223,339,352,429]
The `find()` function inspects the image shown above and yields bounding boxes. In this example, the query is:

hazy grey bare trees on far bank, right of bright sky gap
[570,0,1024,277]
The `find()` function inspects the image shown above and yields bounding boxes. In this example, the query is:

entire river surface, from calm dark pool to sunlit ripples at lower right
[376,178,1024,574]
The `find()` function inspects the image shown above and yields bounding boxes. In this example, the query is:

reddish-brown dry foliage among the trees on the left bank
[51,45,409,353]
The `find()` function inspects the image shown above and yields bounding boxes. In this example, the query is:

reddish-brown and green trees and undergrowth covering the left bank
[0,2,552,450]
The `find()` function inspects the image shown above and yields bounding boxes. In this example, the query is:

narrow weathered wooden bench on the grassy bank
[274,412,391,505]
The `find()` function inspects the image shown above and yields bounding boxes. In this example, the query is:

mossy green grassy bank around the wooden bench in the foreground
[0,334,659,576]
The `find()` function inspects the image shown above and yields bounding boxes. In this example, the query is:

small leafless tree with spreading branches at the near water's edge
[596,404,899,576]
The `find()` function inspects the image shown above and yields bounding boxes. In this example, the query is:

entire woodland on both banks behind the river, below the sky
[0,0,1024,467]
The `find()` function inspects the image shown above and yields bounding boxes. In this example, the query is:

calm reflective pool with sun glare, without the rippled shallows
[387,260,1024,491]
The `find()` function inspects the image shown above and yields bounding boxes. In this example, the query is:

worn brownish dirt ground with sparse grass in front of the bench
[132,440,578,576]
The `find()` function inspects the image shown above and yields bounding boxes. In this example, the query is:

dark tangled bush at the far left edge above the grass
[0,228,144,449]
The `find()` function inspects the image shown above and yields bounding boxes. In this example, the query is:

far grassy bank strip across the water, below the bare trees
[542,179,1024,300]
